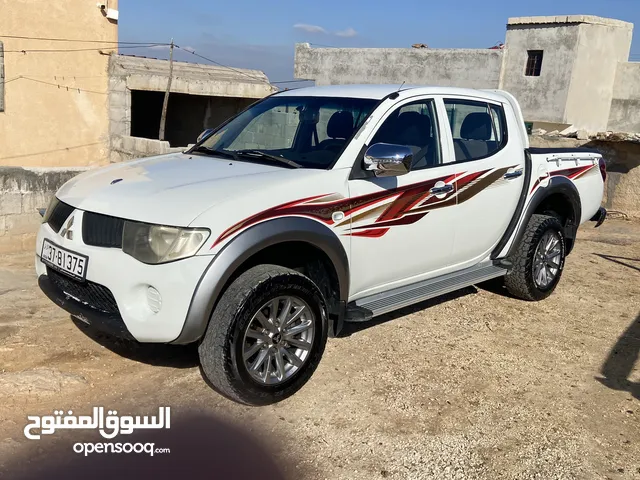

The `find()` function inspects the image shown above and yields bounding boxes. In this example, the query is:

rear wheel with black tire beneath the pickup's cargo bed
[505,214,565,301]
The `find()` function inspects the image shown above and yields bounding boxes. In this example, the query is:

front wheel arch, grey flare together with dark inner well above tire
[171,217,349,344]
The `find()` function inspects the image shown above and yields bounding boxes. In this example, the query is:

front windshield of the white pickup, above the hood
[199,95,377,169]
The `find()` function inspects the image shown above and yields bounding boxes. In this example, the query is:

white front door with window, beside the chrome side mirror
[348,97,459,300]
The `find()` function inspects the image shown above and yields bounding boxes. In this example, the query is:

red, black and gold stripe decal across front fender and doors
[211,165,515,248]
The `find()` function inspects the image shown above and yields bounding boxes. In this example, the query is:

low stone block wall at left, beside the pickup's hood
[0,167,87,254]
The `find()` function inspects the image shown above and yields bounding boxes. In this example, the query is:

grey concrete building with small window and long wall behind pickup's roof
[294,15,640,132]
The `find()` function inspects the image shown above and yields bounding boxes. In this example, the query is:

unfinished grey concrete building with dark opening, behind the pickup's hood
[109,55,276,162]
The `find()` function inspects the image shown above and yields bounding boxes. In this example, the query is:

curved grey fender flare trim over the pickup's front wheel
[171,217,349,344]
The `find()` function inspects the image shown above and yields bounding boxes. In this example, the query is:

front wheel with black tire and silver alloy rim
[198,265,328,405]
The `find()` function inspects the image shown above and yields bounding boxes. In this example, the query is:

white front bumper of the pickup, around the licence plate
[35,216,214,343]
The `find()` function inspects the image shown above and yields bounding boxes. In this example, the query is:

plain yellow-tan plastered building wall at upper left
[0,0,118,167]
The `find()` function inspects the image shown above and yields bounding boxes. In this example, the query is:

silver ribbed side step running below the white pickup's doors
[345,263,507,322]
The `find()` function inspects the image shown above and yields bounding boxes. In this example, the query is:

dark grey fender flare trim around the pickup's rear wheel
[505,176,582,258]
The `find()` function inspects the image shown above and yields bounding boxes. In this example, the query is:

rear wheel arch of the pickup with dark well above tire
[506,176,582,257]
